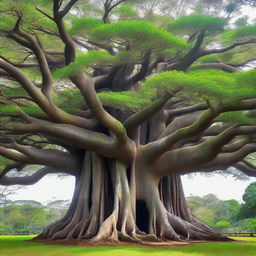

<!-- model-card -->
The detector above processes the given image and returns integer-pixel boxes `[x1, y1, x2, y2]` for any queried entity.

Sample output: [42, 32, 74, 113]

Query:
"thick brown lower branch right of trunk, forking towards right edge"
[157, 126, 256, 176]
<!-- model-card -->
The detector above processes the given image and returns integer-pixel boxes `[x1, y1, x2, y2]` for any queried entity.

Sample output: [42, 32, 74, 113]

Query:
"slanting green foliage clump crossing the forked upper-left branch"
[53, 51, 117, 79]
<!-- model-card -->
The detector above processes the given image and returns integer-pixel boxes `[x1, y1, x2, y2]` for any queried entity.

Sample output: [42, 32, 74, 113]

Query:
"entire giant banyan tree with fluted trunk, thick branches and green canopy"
[0, 0, 256, 242]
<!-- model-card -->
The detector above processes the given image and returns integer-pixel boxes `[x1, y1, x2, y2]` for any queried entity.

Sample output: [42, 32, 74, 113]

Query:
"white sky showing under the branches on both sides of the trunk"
[6, 174, 256, 203]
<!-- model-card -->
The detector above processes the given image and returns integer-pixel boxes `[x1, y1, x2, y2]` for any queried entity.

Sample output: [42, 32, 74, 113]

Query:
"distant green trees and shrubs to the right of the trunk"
[187, 182, 256, 232]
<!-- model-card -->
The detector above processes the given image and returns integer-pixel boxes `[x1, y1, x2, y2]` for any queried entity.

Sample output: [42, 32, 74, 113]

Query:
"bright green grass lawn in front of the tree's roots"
[0, 236, 256, 256]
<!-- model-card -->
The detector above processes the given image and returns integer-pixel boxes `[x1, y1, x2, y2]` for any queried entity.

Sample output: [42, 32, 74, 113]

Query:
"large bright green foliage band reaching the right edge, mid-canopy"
[141, 70, 256, 103]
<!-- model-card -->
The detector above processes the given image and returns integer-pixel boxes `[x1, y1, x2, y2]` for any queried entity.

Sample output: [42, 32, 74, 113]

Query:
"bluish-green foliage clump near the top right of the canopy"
[168, 14, 226, 34]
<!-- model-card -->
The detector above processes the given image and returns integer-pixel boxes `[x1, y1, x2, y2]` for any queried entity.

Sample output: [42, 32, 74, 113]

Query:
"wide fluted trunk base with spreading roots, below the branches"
[35, 152, 229, 244]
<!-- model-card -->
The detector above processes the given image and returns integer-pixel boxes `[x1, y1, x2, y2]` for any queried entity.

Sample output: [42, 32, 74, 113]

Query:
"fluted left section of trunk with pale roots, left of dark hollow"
[37, 152, 135, 241]
